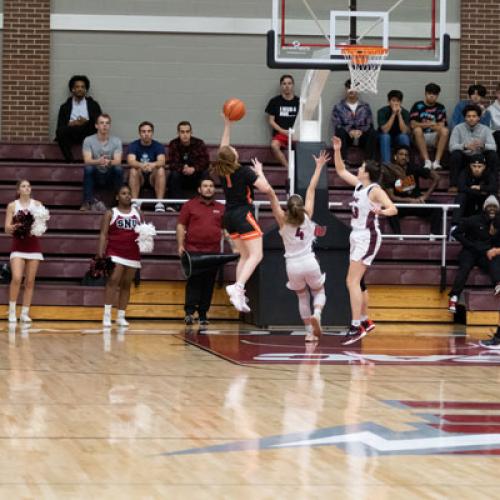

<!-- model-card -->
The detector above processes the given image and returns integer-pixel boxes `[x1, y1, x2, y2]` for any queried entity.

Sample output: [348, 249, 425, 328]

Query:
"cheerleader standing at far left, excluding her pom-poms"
[5, 179, 43, 323]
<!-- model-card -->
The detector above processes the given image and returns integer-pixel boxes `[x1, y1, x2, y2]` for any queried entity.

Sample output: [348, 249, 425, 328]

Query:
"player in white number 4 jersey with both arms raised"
[268, 151, 331, 342]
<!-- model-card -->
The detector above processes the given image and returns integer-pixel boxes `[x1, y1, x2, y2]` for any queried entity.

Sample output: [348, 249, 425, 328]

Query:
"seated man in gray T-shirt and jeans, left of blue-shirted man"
[80, 113, 123, 211]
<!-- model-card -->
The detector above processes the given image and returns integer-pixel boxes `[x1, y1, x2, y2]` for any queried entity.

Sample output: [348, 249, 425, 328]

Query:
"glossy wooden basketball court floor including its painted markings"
[0, 322, 500, 500]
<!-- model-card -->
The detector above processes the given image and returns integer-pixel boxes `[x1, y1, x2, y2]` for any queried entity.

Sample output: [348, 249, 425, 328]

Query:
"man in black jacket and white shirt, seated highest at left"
[56, 75, 102, 163]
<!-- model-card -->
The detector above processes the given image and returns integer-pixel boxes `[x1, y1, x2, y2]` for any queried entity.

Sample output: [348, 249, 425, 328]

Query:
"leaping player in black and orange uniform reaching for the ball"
[213, 116, 271, 312]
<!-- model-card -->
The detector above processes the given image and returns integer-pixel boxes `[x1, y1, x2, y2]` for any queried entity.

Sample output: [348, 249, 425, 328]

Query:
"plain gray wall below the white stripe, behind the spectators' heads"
[51, 32, 459, 144]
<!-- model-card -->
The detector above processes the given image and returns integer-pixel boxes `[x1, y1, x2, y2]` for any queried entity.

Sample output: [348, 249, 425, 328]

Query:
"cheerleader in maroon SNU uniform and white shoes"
[97, 186, 141, 327]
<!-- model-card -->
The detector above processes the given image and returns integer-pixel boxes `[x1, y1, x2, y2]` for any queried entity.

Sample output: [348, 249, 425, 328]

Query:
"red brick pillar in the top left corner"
[1, 0, 50, 142]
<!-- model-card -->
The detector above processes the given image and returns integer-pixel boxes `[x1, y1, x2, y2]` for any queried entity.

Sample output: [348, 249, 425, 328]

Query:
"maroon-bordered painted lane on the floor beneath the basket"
[182, 328, 500, 366]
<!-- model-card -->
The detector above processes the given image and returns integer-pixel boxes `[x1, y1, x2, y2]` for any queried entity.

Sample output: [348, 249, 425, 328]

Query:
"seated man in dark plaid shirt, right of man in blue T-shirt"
[167, 121, 209, 209]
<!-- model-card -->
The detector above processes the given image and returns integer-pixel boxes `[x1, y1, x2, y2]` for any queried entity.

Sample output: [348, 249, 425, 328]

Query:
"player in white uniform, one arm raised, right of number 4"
[332, 137, 398, 345]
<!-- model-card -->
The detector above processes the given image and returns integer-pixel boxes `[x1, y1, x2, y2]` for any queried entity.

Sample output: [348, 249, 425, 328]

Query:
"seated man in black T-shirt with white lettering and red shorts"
[266, 75, 300, 167]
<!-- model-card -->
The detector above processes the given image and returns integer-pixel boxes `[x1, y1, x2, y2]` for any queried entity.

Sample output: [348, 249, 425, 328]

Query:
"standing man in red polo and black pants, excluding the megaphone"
[177, 178, 224, 325]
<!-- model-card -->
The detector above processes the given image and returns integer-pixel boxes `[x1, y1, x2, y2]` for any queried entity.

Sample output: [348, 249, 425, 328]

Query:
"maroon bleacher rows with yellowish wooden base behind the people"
[0, 143, 499, 321]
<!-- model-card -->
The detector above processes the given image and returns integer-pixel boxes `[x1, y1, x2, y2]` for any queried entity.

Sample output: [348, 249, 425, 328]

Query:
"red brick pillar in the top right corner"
[460, 0, 500, 100]
